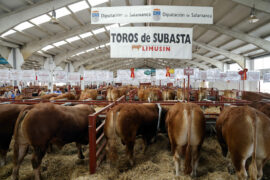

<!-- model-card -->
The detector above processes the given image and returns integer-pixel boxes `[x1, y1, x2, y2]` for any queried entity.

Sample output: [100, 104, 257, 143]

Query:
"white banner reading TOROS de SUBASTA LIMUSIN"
[110, 27, 193, 59]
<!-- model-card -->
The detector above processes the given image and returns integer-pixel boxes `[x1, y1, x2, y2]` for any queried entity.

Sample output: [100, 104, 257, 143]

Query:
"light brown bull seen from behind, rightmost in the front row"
[216, 106, 270, 180]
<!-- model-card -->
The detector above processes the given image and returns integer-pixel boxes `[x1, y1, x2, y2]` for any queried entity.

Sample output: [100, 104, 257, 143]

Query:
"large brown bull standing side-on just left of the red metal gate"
[12, 103, 95, 179]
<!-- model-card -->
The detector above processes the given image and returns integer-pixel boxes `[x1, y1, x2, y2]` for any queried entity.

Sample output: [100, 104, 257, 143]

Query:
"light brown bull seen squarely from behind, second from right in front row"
[166, 103, 205, 176]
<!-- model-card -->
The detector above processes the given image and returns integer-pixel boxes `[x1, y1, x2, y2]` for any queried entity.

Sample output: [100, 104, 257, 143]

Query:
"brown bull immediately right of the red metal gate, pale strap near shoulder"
[104, 104, 167, 165]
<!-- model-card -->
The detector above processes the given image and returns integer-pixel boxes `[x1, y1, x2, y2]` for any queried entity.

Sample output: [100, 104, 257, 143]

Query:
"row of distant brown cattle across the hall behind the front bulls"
[9, 86, 237, 102]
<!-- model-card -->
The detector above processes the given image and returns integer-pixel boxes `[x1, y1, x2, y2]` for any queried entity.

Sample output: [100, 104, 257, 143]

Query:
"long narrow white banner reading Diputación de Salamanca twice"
[91, 5, 213, 24]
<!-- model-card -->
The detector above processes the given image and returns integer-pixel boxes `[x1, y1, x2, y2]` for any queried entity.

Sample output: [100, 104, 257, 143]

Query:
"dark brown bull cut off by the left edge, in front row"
[0, 104, 27, 166]
